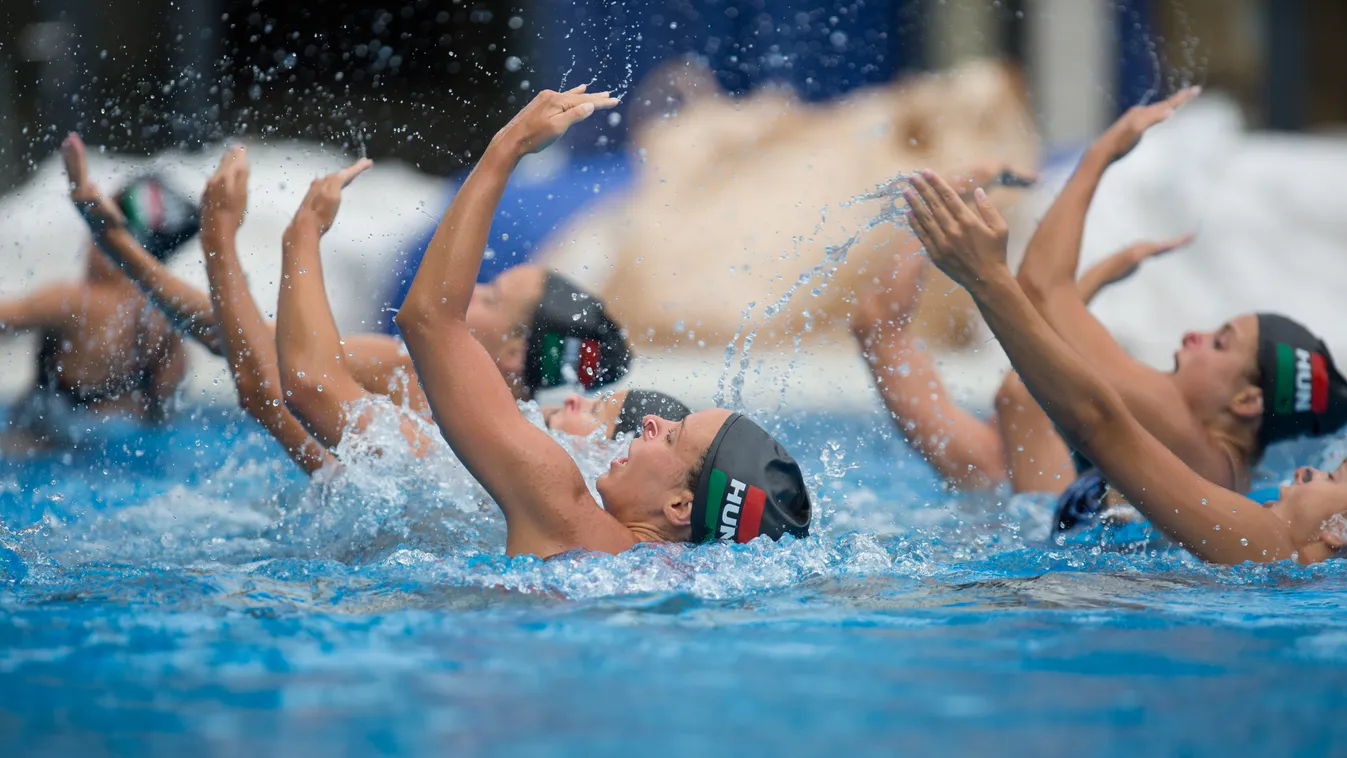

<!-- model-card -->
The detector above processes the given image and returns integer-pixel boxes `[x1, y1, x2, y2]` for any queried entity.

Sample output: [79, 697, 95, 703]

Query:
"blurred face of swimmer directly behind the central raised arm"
[465, 265, 547, 385]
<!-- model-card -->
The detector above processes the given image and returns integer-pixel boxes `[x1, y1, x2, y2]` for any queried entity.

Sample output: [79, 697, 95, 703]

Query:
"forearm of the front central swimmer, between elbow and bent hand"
[397, 140, 519, 332]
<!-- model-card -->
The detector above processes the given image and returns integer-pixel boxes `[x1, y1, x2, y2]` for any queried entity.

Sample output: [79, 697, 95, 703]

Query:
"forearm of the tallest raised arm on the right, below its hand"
[1018, 147, 1110, 302]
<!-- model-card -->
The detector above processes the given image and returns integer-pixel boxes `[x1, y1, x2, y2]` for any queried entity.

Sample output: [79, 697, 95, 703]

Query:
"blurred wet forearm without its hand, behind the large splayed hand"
[862, 334, 1006, 487]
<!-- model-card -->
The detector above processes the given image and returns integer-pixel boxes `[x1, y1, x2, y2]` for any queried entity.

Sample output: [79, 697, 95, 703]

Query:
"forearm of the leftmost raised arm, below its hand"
[94, 226, 224, 355]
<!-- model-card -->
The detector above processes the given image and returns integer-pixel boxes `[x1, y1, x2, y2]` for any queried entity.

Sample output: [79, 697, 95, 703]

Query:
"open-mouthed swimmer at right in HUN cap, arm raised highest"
[851, 89, 1347, 526]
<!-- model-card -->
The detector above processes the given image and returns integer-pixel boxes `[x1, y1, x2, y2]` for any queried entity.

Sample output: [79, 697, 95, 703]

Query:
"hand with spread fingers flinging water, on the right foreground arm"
[902, 170, 1009, 289]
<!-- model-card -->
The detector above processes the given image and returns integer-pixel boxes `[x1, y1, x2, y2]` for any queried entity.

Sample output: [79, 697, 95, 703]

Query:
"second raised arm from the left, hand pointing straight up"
[201, 145, 331, 474]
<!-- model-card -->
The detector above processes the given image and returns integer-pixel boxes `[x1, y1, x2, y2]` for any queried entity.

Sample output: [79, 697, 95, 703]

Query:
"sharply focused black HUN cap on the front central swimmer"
[692, 413, 810, 543]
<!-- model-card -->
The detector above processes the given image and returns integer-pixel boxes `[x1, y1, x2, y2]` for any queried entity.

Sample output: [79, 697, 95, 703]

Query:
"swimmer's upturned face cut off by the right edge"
[1270, 460, 1347, 560]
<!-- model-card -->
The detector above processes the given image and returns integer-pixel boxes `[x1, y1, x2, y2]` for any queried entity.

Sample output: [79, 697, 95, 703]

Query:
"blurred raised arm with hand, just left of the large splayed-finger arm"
[851, 245, 1006, 487]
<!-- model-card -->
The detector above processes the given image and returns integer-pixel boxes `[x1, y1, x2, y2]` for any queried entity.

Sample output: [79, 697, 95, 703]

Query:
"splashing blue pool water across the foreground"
[0, 408, 1347, 757]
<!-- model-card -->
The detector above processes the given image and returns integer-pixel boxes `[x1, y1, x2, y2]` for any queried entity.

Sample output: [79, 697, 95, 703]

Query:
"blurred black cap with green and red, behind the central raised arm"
[524, 272, 632, 393]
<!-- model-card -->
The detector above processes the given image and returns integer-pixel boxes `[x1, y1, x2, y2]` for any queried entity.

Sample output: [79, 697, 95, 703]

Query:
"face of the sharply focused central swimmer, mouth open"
[598, 408, 730, 540]
